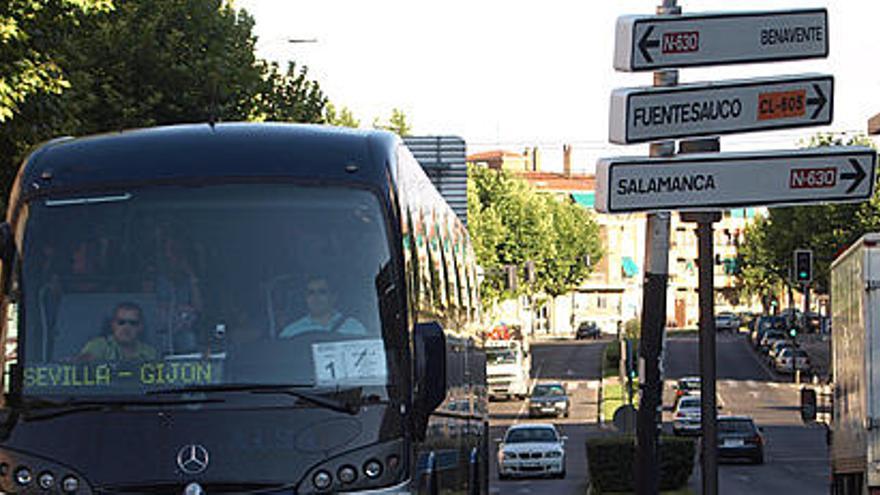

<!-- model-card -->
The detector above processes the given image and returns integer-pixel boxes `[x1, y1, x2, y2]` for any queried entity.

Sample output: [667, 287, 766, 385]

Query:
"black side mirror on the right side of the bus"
[413, 321, 446, 440]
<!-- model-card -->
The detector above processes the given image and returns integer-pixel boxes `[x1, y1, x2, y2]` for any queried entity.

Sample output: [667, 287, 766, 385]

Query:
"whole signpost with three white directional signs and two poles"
[596, 0, 844, 495]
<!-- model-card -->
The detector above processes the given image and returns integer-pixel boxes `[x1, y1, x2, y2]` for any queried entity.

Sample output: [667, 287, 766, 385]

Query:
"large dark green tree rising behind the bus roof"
[0, 0, 327, 202]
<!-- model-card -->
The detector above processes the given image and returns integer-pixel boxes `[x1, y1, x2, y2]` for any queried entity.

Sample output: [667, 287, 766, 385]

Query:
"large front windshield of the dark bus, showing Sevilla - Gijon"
[19, 184, 396, 398]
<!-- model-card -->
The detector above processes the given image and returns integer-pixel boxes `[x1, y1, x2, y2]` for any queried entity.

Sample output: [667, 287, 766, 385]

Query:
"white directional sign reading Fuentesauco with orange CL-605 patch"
[609, 74, 834, 144]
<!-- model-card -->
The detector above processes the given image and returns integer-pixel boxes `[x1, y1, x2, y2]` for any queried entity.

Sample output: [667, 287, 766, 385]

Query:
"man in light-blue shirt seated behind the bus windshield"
[280, 277, 367, 338]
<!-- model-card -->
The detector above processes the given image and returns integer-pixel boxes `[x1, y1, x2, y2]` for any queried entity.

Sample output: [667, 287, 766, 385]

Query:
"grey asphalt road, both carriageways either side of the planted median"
[489, 335, 829, 495]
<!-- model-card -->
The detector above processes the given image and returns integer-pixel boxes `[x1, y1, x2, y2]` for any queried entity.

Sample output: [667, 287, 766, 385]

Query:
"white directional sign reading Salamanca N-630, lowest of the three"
[596, 146, 877, 213]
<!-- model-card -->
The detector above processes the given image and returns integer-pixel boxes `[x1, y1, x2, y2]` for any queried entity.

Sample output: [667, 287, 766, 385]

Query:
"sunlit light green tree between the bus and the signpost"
[468, 166, 601, 301]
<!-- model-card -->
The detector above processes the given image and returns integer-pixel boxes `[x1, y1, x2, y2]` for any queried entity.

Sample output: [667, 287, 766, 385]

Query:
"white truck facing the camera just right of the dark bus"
[486, 339, 532, 399]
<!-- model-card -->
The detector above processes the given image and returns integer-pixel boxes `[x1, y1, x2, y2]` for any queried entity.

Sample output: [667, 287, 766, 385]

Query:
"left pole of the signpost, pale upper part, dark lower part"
[635, 0, 681, 495]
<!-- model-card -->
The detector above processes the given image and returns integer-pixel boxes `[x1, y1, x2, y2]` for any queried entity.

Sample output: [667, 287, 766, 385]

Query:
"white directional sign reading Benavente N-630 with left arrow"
[614, 9, 828, 72]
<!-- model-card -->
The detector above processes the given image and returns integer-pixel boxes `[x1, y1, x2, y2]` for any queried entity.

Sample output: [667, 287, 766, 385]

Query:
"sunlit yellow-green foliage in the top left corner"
[0, 0, 112, 123]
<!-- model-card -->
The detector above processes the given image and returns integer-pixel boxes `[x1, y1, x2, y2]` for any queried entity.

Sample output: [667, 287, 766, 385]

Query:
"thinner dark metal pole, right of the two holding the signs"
[679, 138, 721, 495]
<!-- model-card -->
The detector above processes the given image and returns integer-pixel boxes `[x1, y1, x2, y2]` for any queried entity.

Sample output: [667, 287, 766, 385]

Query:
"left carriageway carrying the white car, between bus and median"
[489, 341, 605, 495]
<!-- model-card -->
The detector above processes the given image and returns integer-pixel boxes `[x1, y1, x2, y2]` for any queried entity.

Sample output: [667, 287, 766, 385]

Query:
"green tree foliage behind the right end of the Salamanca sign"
[738, 134, 880, 295]
